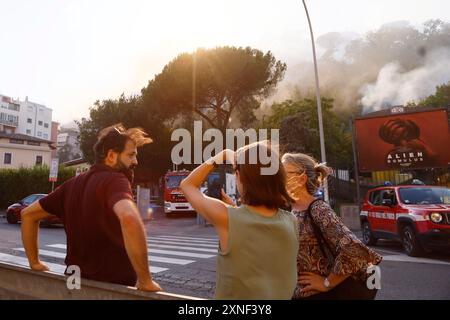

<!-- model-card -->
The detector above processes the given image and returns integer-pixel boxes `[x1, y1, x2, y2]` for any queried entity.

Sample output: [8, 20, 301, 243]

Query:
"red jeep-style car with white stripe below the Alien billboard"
[360, 185, 450, 256]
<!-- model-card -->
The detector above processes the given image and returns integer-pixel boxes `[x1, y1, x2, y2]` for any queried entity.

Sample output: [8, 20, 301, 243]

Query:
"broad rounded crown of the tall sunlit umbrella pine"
[142, 47, 286, 132]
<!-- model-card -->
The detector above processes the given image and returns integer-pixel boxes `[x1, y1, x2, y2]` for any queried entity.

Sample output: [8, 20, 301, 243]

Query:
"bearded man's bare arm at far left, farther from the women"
[21, 201, 50, 271]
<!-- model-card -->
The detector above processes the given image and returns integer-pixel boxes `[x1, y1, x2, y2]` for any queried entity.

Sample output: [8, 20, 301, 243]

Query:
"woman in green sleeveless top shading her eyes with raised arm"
[181, 142, 299, 300]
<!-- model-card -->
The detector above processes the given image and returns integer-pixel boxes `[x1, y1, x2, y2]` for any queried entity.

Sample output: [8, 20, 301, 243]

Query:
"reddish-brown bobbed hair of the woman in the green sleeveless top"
[235, 141, 293, 209]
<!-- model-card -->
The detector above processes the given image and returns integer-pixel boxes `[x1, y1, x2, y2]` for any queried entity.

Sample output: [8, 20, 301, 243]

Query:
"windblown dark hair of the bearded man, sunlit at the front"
[94, 123, 153, 163]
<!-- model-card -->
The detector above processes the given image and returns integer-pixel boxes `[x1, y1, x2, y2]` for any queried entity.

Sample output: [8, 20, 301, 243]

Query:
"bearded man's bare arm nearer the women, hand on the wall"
[113, 199, 162, 291]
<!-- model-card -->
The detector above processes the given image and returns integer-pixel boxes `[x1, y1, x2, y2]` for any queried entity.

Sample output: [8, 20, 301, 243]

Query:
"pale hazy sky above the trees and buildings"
[0, 0, 450, 124]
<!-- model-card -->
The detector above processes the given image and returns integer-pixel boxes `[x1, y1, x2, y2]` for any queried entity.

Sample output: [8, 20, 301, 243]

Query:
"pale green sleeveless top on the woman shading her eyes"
[215, 205, 299, 300]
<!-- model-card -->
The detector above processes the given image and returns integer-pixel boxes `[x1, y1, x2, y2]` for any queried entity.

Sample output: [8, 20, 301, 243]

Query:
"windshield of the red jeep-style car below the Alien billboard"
[400, 187, 450, 204]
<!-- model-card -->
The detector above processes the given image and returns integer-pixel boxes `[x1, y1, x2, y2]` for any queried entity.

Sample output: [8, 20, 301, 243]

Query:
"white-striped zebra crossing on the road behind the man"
[0, 235, 219, 274]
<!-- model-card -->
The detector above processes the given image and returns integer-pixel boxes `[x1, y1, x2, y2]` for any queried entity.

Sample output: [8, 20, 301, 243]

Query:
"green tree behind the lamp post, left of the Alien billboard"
[262, 98, 352, 168]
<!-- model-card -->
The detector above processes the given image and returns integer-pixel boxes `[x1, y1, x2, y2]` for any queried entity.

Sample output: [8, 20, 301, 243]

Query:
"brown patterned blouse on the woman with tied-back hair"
[293, 200, 382, 299]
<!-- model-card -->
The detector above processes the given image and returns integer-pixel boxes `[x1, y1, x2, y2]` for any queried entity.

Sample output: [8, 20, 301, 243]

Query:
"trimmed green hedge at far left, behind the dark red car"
[0, 166, 75, 210]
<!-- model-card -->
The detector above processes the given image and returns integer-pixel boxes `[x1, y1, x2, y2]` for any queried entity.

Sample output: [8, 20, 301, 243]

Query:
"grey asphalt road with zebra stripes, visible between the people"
[0, 207, 450, 300]
